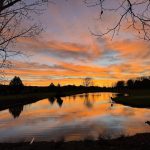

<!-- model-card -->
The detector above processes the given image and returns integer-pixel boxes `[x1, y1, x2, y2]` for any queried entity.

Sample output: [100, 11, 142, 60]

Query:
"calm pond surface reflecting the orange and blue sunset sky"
[0, 93, 150, 142]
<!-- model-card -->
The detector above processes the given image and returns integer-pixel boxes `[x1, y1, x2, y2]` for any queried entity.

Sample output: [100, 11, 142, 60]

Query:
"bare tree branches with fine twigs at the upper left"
[0, 0, 52, 68]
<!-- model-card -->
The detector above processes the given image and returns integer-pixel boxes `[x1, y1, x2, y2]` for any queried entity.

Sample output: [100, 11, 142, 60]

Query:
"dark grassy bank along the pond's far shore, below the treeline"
[0, 88, 150, 110]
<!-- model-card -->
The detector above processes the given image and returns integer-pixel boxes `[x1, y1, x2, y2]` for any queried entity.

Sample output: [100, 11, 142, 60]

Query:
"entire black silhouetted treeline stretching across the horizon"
[0, 77, 150, 95]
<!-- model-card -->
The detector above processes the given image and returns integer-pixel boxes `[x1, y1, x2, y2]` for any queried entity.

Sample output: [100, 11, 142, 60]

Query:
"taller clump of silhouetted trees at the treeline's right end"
[115, 76, 150, 89]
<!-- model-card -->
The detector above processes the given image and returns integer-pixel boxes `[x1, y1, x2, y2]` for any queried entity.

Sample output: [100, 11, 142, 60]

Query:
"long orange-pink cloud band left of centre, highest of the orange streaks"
[18, 38, 101, 60]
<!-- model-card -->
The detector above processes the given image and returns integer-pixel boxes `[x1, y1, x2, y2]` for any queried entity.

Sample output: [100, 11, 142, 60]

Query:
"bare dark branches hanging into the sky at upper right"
[84, 0, 150, 40]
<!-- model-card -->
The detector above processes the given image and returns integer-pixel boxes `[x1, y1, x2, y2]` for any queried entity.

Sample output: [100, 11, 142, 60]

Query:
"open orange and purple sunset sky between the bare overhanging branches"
[6, 0, 150, 86]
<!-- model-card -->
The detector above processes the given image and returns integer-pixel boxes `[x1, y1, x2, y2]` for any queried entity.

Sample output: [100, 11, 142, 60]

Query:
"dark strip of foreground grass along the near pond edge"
[0, 133, 150, 150]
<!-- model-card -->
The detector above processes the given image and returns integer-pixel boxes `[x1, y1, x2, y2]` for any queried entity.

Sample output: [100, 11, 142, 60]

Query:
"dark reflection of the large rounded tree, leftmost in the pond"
[9, 105, 23, 118]
